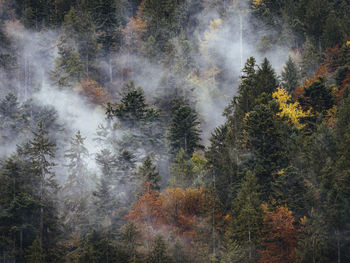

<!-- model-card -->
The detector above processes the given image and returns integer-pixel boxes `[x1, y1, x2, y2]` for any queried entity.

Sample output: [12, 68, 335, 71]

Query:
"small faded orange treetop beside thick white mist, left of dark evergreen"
[77, 80, 107, 104]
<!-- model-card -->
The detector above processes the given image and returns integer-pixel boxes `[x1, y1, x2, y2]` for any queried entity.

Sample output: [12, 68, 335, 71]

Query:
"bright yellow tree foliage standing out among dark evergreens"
[272, 88, 311, 129]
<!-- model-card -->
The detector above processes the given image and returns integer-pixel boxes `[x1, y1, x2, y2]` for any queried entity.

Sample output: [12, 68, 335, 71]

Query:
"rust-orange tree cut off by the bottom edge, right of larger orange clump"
[259, 206, 299, 263]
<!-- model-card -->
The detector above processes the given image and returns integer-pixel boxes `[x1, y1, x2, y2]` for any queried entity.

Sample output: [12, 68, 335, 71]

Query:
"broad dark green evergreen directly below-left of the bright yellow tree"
[244, 104, 290, 200]
